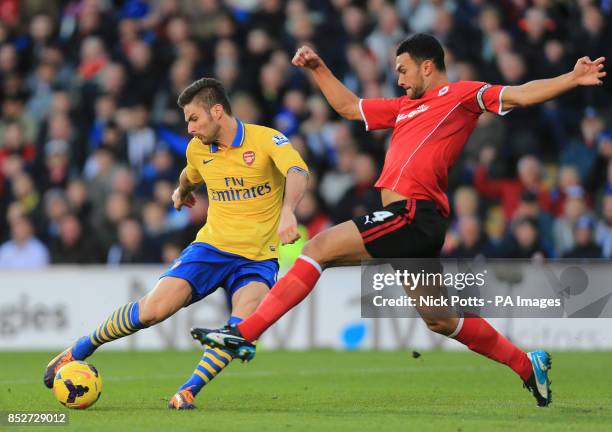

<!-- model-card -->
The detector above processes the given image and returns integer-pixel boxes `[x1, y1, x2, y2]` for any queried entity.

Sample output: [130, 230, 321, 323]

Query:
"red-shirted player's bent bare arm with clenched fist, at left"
[291, 46, 363, 120]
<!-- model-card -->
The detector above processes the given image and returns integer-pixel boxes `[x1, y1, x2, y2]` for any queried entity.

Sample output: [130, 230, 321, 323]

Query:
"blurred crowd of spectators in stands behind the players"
[0, 0, 612, 268]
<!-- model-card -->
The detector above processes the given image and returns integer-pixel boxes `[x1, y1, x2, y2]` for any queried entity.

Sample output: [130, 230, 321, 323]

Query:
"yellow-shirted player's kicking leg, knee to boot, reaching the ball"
[43, 277, 191, 388]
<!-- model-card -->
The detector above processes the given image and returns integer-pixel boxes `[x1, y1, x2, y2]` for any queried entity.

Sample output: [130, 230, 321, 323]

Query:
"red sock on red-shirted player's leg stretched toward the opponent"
[238, 256, 321, 342]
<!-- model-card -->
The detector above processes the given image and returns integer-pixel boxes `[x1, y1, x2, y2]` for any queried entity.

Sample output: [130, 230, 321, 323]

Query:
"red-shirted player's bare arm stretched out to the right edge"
[502, 57, 606, 111]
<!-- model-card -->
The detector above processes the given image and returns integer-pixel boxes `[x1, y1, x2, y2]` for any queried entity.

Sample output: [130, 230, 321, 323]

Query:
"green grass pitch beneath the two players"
[0, 350, 612, 432]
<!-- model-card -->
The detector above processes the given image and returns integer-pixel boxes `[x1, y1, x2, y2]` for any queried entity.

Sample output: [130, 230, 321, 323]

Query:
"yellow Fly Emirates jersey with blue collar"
[186, 119, 308, 261]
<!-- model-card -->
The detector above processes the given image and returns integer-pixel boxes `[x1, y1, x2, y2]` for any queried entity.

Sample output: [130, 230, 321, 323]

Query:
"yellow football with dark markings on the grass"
[53, 361, 102, 409]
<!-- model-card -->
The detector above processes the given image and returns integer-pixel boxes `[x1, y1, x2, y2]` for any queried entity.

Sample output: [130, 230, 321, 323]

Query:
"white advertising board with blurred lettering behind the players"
[0, 266, 612, 351]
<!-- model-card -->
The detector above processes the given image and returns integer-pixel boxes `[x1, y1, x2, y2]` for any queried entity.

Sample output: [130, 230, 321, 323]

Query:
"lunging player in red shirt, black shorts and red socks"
[192, 34, 606, 406]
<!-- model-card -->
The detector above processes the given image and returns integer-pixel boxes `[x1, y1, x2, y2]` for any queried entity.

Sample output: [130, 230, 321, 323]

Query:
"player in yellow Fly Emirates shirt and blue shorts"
[44, 78, 308, 409]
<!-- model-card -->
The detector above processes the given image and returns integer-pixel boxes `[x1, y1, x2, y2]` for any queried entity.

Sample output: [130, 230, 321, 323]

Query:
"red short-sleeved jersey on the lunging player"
[359, 81, 508, 216]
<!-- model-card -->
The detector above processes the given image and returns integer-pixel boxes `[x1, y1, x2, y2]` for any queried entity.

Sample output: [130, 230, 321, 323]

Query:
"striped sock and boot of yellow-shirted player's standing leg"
[168, 316, 242, 410]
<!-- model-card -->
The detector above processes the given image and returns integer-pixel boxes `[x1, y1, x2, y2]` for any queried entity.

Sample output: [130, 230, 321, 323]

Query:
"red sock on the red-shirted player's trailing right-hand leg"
[451, 314, 532, 381]
